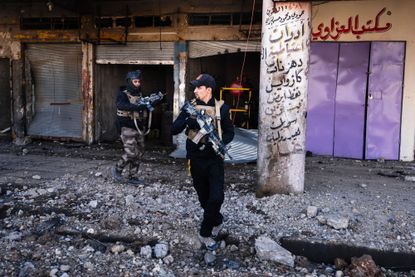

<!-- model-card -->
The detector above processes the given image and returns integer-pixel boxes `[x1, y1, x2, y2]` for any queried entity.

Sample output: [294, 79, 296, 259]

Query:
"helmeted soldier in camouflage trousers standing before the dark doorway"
[112, 70, 148, 184]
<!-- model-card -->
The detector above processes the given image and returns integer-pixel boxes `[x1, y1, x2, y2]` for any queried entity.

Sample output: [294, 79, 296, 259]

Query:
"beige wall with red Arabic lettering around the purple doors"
[312, 0, 415, 161]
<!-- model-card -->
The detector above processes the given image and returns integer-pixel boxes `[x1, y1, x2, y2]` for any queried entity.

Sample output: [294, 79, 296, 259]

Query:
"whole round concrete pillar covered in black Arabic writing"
[256, 0, 311, 197]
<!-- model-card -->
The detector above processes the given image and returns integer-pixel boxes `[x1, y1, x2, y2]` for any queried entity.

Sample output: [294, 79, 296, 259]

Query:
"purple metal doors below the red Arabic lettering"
[306, 42, 405, 160]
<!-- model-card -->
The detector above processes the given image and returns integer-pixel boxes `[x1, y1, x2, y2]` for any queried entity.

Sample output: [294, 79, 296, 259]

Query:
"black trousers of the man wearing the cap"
[190, 156, 225, 237]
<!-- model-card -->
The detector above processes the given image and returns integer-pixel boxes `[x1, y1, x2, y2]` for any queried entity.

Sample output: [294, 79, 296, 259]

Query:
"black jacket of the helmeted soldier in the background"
[116, 87, 145, 130]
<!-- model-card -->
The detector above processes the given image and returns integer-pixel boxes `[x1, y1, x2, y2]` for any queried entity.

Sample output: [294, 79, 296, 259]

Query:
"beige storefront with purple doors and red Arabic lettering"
[307, 1, 415, 160]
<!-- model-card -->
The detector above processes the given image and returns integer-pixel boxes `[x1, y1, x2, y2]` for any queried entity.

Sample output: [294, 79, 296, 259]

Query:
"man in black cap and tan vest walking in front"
[171, 74, 234, 250]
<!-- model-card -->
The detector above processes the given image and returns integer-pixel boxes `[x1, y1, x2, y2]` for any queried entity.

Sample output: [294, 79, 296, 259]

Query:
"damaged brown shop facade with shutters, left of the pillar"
[0, 0, 262, 146]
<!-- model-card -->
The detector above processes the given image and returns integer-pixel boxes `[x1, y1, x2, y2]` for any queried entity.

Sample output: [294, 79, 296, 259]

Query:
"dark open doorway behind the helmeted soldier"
[95, 64, 174, 144]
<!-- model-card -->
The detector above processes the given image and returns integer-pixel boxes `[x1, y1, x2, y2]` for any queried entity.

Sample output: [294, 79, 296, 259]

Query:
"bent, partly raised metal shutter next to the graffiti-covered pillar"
[189, 41, 261, 58]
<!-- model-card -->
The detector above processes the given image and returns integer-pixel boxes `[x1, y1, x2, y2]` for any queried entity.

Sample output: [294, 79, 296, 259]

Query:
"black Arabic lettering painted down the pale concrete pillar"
[261, 2, 311, 154]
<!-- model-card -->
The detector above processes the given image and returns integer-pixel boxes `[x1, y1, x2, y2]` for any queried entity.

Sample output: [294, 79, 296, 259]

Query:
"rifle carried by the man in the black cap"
[182, 101, 232, 160]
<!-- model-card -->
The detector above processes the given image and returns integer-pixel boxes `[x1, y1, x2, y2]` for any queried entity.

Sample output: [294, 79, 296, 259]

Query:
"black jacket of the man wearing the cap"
[171, 97, 235, 159]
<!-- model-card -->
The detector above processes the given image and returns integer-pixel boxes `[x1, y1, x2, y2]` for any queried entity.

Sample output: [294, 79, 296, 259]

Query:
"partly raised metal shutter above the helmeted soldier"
[96, 42, 174, 64]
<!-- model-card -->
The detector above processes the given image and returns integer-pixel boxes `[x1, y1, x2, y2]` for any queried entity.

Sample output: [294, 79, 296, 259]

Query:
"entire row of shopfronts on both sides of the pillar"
[0, 0, 415, 161]
